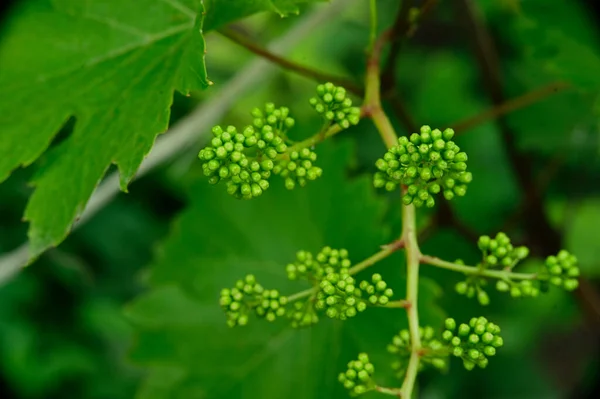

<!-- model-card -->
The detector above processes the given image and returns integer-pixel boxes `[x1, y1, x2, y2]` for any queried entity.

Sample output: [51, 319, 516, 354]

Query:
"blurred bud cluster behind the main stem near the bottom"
[387, 326, 448, 378]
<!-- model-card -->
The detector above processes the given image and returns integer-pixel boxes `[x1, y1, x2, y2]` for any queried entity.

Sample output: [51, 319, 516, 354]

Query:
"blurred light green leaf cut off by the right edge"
[565, 198, 600, 278]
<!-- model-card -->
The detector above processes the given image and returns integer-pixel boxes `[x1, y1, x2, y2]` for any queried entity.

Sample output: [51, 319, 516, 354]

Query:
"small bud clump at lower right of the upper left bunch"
[273, 148, 323, 190]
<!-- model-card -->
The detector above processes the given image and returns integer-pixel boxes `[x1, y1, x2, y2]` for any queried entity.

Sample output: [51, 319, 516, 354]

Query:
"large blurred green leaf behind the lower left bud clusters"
[127, 145, 442, 399]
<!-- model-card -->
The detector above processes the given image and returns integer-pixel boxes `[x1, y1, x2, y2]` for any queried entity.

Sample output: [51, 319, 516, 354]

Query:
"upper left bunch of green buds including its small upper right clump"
[198, 83, 360, 199]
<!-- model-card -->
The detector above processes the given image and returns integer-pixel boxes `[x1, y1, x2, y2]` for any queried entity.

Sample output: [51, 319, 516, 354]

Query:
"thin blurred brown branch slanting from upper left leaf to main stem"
[219, 29, 364, 97]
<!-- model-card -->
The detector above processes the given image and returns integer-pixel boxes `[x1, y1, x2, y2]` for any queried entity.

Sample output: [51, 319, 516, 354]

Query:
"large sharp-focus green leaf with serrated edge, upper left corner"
[0, 0, 208, 256]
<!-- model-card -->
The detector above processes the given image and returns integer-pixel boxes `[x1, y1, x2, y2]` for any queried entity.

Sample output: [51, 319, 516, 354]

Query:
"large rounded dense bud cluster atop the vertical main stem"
[373, 126, 473, 207]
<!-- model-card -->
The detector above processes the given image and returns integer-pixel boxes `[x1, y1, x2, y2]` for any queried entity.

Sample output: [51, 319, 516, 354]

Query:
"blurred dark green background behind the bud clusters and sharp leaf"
[0, 0, 600, 399]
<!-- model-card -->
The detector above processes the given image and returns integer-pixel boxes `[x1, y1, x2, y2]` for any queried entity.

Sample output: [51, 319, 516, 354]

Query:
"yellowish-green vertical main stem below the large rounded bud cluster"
[401, 198, 421, 399]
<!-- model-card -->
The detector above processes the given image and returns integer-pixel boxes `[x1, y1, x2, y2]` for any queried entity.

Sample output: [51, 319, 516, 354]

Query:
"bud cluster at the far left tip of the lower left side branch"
[219, 274, 287, 327]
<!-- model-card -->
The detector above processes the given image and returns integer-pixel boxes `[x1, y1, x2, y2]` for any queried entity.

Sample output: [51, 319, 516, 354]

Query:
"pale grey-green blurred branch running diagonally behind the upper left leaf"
[0, 0, 357, 284]
